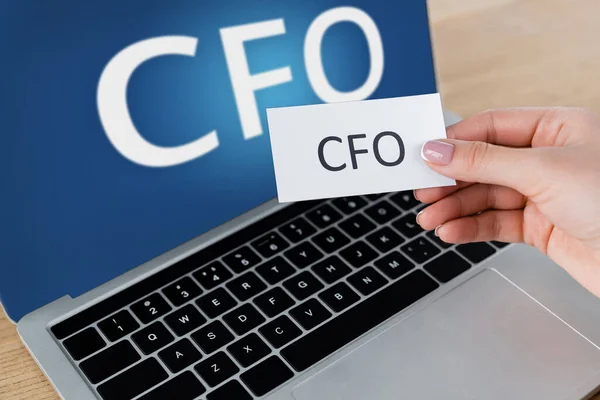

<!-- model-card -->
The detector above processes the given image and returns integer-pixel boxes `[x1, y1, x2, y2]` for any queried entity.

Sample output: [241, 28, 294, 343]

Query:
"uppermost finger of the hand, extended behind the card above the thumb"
[447, 107, 581, 147]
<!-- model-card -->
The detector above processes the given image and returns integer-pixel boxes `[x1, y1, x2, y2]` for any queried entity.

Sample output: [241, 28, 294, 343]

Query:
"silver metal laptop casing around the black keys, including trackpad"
[18, 110, 600, 400]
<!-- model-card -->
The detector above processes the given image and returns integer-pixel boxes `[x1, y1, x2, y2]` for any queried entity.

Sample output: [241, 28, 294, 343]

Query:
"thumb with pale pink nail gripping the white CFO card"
[421, 139, 549, 196]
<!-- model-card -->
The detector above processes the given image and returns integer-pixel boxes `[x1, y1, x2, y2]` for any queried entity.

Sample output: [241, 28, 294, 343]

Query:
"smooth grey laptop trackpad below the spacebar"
[293, 270, 600, 400]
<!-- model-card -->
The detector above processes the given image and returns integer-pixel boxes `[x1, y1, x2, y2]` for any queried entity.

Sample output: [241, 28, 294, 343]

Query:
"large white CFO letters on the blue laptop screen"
[97, 7, 384, 167]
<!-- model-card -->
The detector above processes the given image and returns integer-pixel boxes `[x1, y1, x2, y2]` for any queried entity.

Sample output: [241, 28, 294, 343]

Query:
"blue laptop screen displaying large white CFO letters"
[0, 0, 436, 320]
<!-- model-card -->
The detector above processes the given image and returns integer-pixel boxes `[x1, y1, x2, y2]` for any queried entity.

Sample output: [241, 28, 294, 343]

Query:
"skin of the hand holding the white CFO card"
[415, 108, 600, 297]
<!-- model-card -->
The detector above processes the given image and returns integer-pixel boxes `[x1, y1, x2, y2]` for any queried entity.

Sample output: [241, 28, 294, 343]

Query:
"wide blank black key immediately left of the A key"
[98, 358, 169, 400]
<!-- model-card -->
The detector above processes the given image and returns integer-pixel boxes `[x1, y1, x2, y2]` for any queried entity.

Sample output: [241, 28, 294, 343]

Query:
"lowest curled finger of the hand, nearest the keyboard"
[436, 210, 523, 244]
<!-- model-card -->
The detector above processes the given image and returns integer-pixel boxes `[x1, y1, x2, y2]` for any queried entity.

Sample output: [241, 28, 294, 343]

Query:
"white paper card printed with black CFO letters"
[267, 94, 456, 203]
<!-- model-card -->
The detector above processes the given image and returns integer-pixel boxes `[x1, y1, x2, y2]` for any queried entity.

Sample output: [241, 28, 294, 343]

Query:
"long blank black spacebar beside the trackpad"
[281, 270, 439, 371]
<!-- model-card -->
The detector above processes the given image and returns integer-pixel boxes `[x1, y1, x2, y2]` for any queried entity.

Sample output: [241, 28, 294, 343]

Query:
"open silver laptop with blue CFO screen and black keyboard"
[5, 0, 600, 400]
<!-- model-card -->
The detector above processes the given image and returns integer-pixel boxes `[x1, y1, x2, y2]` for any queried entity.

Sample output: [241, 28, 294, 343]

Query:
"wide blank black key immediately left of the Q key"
[79, 340, 141, 384]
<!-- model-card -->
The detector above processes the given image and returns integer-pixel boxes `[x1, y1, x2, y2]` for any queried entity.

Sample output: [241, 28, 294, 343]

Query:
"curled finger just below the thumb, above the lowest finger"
[417, 184, 526, 230]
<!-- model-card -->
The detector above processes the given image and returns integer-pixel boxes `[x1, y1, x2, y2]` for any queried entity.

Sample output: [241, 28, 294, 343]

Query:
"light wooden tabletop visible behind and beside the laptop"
[0, 0, 600, 400]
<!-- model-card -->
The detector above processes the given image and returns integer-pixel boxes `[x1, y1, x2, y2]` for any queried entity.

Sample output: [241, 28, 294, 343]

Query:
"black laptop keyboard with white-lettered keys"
[51, 192, 505, 400]
